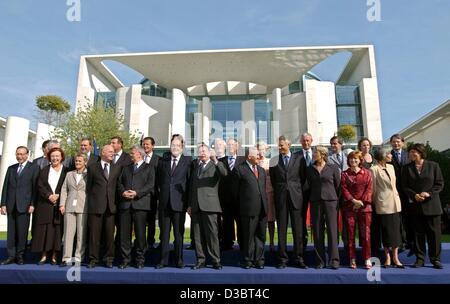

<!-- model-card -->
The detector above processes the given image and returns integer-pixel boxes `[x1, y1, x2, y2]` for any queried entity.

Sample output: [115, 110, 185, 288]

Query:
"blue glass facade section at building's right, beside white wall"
[336, 86, 364, 139]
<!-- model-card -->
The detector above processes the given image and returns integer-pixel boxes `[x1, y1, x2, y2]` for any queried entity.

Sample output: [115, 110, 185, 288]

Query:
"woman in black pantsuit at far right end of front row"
[402, 144, 444, 269]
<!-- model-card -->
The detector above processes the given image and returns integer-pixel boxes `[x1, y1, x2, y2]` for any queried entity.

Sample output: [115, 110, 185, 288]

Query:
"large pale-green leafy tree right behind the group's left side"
[52, 105, 138, 156]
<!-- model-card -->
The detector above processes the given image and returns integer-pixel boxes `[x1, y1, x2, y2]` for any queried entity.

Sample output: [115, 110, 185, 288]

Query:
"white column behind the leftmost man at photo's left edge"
[0, 116, 30, 231]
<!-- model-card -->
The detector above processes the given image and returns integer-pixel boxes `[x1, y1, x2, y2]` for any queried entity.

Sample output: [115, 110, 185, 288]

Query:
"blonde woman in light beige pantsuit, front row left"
[60, 153, 88, 267]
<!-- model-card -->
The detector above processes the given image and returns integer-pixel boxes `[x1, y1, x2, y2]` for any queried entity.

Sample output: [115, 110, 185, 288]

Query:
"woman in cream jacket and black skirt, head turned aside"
[370, 148, 404, 268]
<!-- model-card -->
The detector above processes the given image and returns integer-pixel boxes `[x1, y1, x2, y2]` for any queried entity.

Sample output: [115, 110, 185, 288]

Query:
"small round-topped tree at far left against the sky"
[36, 95, 70, 127]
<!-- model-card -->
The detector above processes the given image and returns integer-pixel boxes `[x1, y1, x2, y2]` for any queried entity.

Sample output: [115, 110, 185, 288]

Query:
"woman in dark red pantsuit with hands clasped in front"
[341, 151, 372, 269]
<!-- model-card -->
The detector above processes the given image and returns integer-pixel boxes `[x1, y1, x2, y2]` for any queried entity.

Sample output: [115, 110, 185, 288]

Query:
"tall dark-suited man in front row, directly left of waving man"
[155, 135, 192, 269]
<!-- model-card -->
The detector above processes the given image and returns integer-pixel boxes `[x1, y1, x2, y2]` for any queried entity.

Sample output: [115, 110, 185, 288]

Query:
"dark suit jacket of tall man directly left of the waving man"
[156, 155, 192, 212]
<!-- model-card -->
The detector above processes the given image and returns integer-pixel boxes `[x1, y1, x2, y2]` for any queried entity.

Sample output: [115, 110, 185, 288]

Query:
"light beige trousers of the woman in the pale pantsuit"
[62, 212, 88, 263]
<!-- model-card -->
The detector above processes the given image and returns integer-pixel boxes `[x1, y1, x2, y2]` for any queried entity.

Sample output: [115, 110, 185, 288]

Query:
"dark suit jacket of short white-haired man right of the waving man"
[231, 162, 268, 216]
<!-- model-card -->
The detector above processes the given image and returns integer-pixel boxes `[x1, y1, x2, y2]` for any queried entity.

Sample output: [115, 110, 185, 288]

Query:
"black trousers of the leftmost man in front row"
[7, 206, 30, 258]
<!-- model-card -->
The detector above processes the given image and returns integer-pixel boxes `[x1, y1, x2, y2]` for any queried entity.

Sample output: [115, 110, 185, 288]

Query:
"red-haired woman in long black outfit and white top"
[31, 148, 67, 265]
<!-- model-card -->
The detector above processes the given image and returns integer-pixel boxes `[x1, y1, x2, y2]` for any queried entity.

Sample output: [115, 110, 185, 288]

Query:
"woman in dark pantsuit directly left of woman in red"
[306, 146, 341, 269]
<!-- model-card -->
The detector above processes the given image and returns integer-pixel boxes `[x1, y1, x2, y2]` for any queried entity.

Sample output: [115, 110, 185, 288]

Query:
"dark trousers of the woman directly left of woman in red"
[311, 201, 339, 265]
